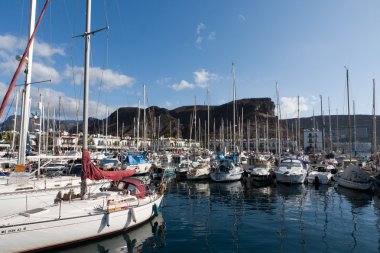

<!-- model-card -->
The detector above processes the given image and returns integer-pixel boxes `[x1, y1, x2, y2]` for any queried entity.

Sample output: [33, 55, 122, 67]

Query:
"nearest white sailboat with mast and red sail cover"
[0, 0, 165, 252]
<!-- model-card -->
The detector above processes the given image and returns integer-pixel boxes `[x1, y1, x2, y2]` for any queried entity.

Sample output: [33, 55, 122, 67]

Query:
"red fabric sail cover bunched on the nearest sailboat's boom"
[82, 150, 135, 180]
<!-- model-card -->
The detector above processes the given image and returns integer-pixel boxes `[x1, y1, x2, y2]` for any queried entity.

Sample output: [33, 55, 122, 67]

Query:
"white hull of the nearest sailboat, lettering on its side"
[0, 196, 163, 252]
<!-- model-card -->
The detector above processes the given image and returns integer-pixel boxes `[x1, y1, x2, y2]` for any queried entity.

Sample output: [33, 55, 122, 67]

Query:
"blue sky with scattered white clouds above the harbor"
[0, 0, 380, 119]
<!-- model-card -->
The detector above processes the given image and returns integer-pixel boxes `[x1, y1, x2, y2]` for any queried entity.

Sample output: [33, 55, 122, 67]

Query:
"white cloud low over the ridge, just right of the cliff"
[280, 97, 309, 119]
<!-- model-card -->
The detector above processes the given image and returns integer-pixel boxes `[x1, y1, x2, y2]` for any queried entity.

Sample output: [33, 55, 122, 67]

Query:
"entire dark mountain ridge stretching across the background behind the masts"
[2, 98, 380, 146]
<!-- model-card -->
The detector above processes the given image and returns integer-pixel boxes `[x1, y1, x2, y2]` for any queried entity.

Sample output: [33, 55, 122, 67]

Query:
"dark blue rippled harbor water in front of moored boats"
[54, 180, 380, 253]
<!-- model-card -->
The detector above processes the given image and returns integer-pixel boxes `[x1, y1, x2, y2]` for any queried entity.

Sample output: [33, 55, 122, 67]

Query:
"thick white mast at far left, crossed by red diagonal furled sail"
[18, 0, 36, 164]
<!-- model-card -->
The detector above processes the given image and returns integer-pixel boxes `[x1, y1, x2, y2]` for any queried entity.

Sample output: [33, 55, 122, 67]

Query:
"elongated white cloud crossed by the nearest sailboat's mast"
[65, 65, 135, 91]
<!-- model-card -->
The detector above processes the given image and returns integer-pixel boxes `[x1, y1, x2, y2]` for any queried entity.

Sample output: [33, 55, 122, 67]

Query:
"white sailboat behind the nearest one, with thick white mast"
[0, 1, 108, 217]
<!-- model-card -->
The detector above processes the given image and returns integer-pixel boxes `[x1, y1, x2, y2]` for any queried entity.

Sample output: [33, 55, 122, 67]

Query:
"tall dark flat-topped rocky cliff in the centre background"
[83, 98, 276, 139]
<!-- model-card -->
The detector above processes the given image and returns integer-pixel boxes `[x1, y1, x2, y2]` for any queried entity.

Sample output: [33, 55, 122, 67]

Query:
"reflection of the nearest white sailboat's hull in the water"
[54, 214, 166, 253]
